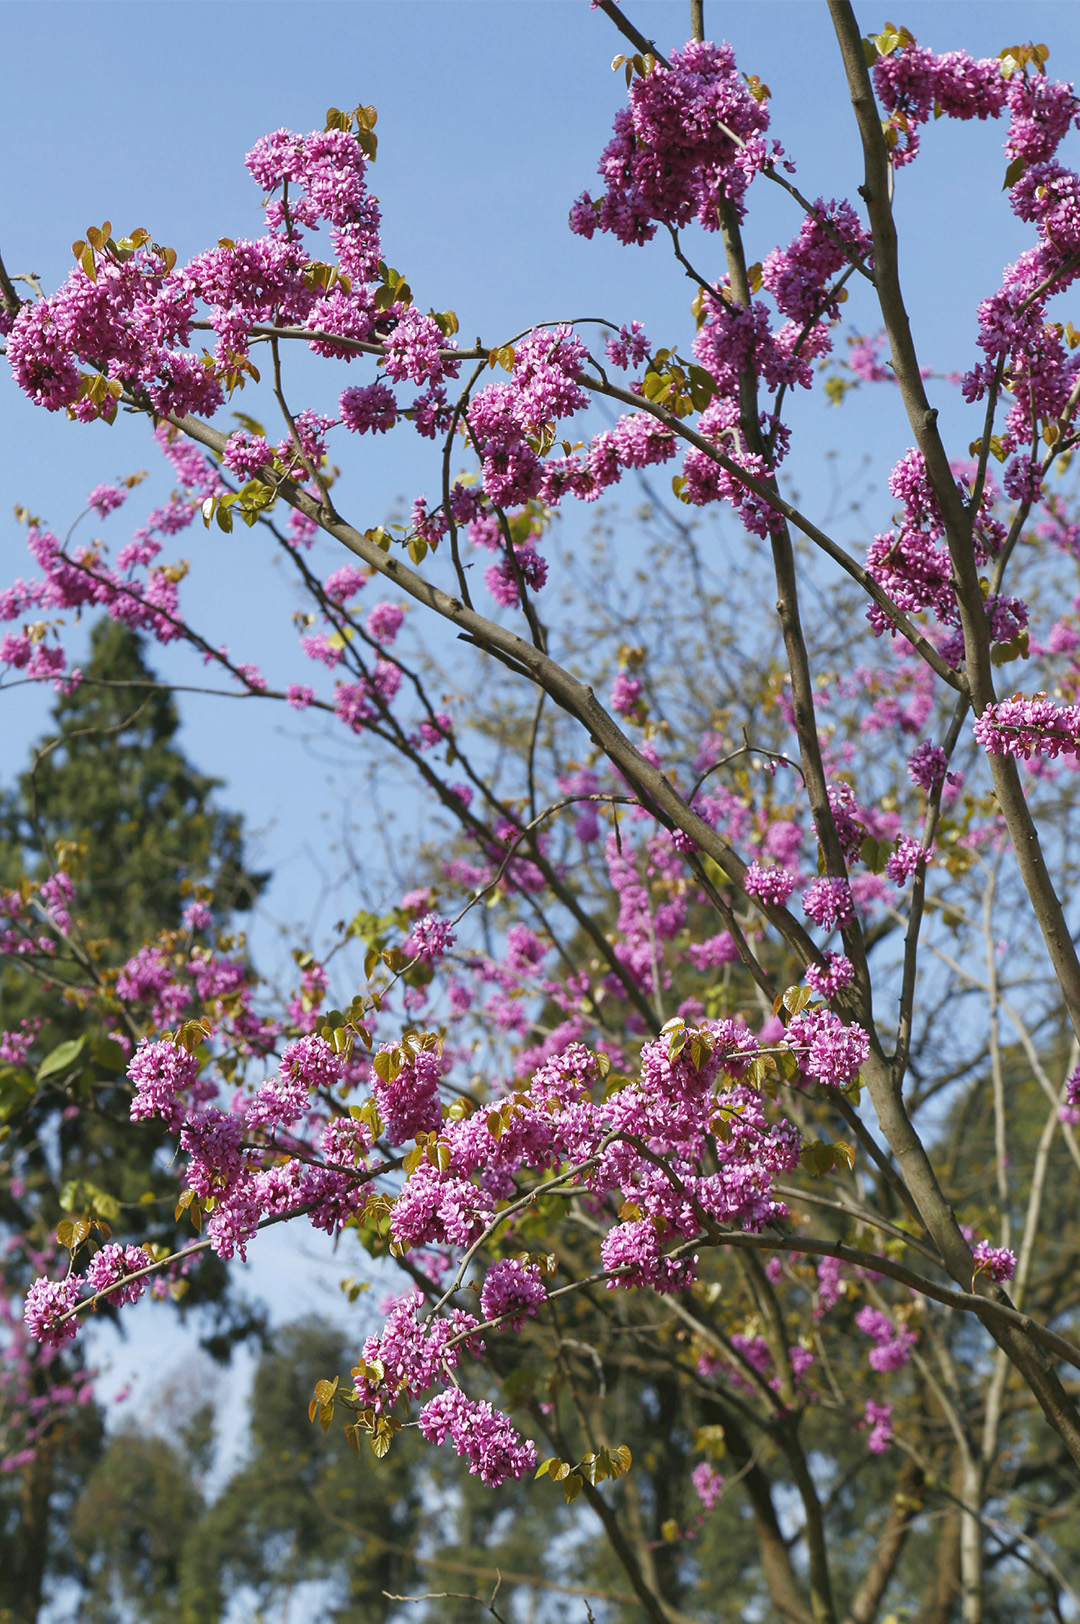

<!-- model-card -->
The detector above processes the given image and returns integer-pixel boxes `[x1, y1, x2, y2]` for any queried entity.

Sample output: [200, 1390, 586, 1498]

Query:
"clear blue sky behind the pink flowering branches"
[0, 0, 1080, 1448]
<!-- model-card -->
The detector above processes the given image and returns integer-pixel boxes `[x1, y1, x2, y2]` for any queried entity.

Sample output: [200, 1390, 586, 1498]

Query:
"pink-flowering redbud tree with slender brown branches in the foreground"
[0, 0, 1080, 1624]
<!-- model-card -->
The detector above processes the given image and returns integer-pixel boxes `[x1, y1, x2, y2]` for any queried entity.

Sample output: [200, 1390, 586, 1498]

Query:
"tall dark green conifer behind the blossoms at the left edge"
[0, 620, 265, 1624]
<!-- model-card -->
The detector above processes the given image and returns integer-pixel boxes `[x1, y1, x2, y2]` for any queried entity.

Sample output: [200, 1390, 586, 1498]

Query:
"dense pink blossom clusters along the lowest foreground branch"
[24, 993, 867, 1483]
